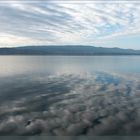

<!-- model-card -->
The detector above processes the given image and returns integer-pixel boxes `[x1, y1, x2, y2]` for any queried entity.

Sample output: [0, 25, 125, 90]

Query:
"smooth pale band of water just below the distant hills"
[0, 56, 140, 76]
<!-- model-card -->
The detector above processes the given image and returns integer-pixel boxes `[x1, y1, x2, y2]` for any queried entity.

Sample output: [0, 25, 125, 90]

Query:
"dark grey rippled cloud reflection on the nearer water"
[0, 73, 140, 136]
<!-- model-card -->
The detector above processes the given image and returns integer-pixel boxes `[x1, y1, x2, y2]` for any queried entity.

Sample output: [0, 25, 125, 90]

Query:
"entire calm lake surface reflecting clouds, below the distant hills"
[0, 56, 140, 135]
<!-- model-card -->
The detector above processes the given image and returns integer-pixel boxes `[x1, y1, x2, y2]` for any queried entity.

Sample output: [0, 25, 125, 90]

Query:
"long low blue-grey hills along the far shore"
[0, 45, 140, 56]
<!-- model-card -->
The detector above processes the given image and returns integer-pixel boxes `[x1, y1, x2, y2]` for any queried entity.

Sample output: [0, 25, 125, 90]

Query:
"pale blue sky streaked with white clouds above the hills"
[0, 0, 140, 49]
